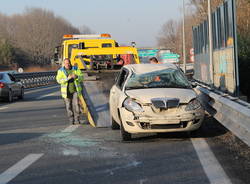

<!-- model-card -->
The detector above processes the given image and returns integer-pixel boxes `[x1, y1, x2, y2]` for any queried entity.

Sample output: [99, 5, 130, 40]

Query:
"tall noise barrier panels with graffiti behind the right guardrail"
[193, 0, 239, 95]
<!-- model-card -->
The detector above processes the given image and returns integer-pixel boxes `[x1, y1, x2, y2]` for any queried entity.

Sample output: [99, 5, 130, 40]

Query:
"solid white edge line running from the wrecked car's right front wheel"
[191, 138, 232, 184]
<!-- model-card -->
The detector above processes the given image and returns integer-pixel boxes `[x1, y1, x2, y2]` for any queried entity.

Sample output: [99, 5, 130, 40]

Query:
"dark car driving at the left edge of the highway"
[0, 72, 24, 102]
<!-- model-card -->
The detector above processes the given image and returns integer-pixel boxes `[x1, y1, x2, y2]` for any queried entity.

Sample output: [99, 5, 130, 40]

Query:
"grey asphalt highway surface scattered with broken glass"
[0, 77, 250, 184]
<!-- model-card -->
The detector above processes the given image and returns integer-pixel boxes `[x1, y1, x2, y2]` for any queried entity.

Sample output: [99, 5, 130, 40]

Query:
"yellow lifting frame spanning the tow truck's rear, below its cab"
[70, 47, 140, 70]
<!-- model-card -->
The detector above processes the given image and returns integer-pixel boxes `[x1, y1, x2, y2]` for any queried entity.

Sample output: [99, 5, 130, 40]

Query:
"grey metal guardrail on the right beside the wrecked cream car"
[197, 84, 250, 146]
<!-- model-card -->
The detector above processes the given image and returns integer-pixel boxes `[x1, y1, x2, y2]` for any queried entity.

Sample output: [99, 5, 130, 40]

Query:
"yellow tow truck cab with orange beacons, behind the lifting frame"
[53, 34, 119, 69]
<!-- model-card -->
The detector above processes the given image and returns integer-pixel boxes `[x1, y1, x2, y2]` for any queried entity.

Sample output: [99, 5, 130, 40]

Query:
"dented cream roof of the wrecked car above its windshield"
[124, 63, 178, 74]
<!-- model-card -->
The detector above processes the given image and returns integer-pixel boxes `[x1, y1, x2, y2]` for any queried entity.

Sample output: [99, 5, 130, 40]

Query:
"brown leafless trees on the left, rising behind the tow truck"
[0, 8, 79, 65]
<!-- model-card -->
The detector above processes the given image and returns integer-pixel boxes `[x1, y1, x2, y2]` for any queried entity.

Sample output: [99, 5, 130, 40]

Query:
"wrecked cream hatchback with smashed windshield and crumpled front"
[109, 64, 204, 140]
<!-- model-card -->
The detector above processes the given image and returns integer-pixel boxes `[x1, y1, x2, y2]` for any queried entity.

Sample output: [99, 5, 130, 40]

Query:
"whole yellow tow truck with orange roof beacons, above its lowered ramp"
[53, 33, 139, 70]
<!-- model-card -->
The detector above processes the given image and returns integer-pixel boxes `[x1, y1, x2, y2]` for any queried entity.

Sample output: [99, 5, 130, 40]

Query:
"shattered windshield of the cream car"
[125, 68, 191, 90]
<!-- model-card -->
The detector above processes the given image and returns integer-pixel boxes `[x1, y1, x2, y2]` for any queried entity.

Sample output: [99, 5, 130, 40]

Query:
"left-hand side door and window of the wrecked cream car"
[109, 68, 129, 122]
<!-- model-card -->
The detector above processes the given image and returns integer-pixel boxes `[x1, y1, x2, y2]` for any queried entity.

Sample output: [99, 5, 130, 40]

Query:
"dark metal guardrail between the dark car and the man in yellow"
[12, 71, 56, 88]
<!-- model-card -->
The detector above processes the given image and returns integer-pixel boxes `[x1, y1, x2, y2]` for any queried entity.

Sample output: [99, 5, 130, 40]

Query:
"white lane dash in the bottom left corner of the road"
[0, 154, 43, 184]
